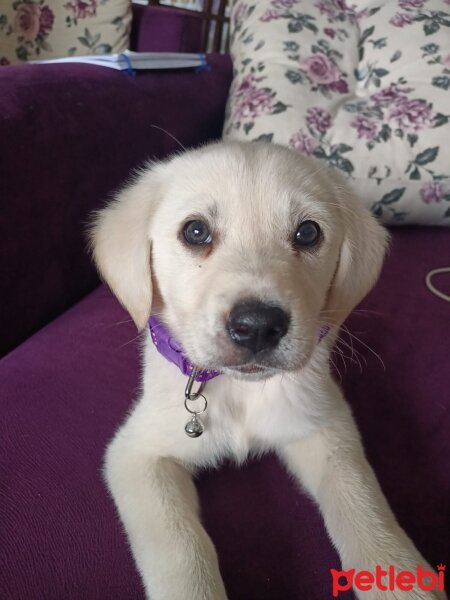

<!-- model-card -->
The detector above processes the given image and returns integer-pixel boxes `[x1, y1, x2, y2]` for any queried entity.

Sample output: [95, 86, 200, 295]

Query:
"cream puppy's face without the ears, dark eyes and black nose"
[150, 146, 342, 377]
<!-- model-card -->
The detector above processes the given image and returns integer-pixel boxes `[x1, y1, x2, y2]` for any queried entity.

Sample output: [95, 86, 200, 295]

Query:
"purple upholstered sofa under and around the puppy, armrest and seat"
[0, 9, 450, 600]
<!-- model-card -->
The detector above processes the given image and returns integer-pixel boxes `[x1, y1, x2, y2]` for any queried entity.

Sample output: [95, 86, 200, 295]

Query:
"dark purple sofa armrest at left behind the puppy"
[0, 55, 231, 354]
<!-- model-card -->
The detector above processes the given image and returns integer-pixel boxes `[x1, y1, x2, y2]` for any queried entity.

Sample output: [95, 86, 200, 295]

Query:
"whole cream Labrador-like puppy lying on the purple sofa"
[91, 143, 440, 600]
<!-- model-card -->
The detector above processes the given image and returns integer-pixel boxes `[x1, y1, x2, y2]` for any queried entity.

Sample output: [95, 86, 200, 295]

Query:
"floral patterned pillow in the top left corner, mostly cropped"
[0, 0, 131, 65]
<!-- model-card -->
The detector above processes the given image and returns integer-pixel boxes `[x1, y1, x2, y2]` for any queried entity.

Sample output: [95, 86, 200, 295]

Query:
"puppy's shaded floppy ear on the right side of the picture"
[326, 183, 389, 325]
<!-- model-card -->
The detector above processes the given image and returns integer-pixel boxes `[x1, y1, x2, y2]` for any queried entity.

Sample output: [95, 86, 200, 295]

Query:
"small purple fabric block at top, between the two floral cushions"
[130, 5, 202, 52]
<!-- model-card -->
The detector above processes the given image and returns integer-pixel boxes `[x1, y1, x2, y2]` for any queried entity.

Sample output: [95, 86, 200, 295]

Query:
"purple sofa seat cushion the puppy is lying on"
[0, 228, 450, 600]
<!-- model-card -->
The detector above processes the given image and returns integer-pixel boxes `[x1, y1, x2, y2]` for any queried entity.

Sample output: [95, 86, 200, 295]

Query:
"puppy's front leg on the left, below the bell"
[105, 416, 226, 600]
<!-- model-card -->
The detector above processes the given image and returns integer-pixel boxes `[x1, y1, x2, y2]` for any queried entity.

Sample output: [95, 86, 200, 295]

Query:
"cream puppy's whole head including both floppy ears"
[92, 143, 387, 378]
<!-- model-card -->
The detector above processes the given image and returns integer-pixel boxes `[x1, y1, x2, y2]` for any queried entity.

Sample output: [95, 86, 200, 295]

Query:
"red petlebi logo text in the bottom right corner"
[330, 564, 445, 598]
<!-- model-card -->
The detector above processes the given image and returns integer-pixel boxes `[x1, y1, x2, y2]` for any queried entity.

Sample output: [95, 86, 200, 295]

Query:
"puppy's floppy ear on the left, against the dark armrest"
[89, 171, 160, 329]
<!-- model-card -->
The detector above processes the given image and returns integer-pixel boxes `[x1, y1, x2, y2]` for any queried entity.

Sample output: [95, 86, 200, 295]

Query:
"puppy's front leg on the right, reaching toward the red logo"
[279, 387, 446, 600]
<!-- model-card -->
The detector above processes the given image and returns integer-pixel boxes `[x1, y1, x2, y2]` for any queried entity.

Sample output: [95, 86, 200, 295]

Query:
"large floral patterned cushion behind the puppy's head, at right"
[224, 0, 450, 225]
